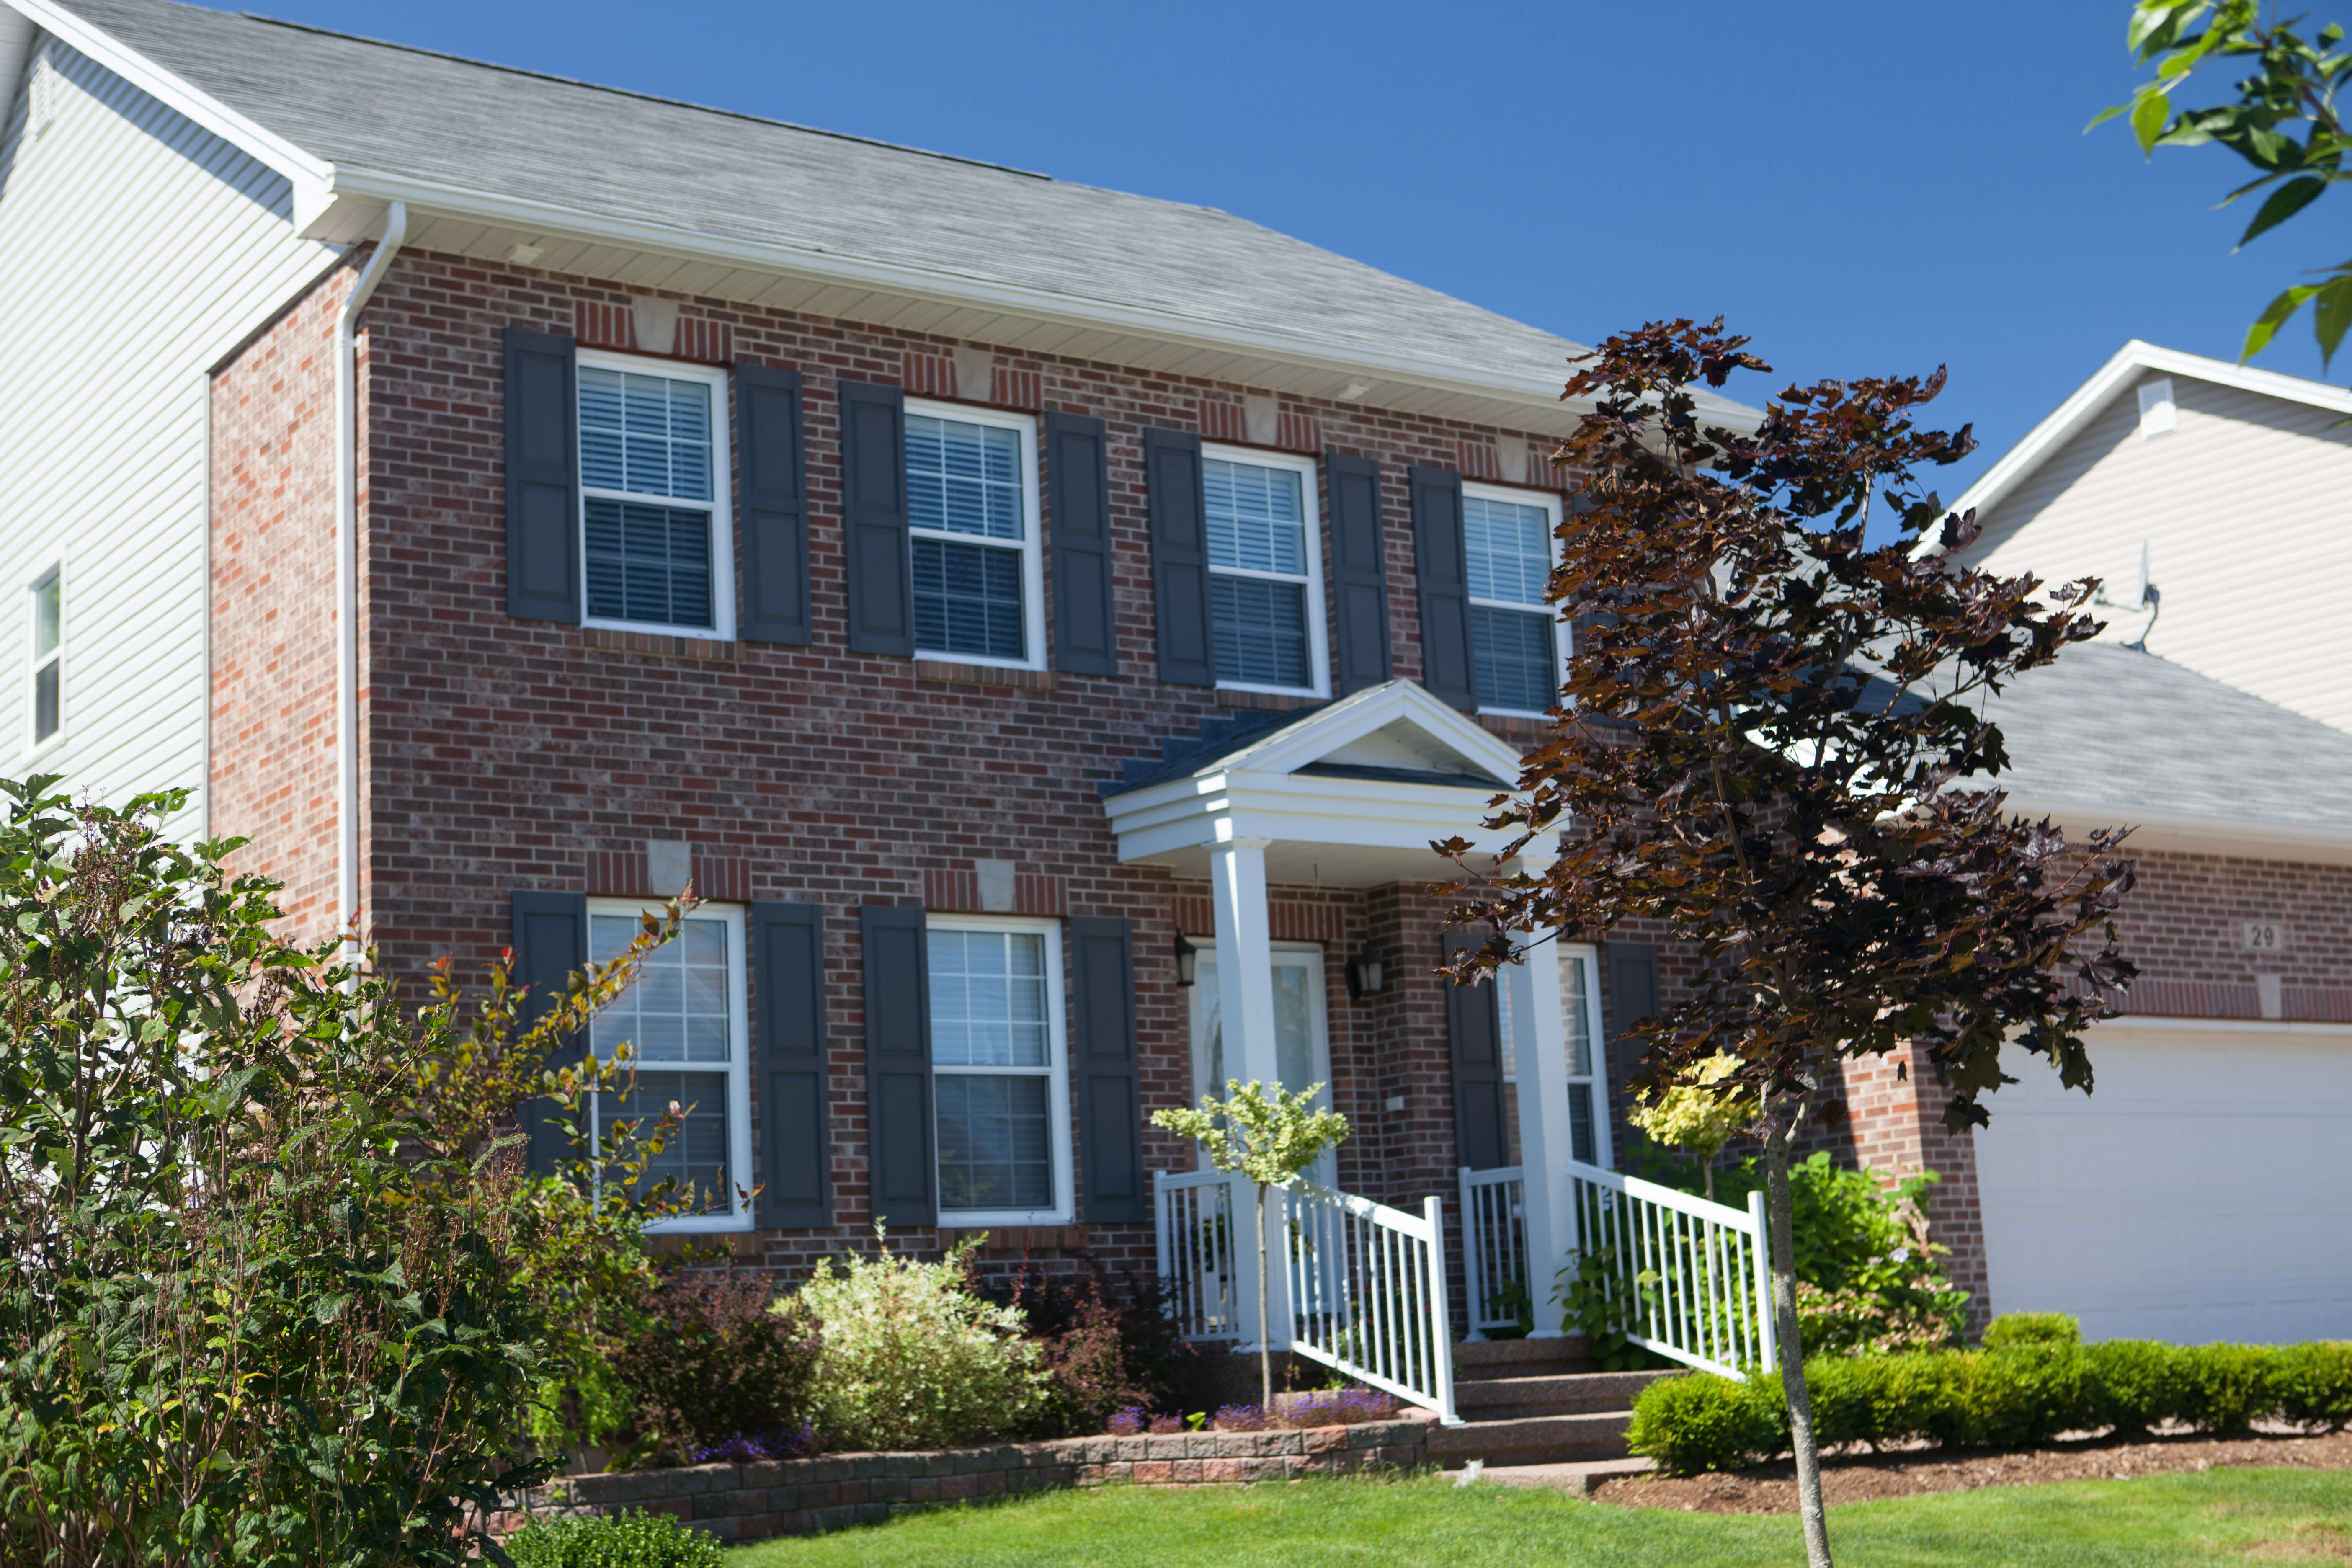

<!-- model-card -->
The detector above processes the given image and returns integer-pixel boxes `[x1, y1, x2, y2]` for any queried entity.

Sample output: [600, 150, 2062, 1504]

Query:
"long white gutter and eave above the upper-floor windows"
[308, 170, 1755, 428]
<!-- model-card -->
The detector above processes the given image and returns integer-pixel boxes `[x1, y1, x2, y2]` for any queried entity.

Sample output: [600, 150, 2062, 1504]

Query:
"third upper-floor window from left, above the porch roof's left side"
[1199, 447, 1329, 696]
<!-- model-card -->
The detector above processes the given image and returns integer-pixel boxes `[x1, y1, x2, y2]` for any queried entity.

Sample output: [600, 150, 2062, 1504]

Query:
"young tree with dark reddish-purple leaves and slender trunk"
[1439, 320, 2133, 1565]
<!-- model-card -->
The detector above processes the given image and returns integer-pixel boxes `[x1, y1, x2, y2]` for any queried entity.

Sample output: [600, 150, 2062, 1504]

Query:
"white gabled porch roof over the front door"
[1103, 679, 1519, 886]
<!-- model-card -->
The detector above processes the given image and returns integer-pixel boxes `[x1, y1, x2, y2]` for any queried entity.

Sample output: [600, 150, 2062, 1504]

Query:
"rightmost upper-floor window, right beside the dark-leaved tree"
[1463, 484, 1566, 717]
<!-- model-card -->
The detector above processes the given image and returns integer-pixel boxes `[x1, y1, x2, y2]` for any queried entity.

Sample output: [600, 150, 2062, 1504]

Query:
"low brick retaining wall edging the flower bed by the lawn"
[489, 1420, 1428, 1540]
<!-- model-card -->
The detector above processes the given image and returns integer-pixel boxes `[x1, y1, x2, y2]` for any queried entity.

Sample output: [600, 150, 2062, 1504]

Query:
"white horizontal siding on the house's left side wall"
[0, 40, 334, 837]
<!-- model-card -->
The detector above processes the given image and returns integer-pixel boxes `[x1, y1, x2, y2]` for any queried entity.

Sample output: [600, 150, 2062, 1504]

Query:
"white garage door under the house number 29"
[1975, 1023, 2352, 1345]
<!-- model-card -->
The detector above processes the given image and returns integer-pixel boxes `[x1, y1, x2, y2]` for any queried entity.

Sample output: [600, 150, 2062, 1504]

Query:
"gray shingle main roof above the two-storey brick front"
[61, 0, 1741, 425]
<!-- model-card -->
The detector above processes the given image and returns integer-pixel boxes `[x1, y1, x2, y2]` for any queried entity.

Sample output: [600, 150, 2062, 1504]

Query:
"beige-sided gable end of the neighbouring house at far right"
[1957, 343, 2352, 729]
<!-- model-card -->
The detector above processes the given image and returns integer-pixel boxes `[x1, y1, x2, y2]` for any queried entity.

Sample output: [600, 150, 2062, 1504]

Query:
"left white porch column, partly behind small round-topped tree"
[1209, 839, 1291, 1352]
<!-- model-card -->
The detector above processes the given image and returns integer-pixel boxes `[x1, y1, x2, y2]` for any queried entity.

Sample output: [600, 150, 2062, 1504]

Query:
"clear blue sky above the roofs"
[253, 0, 2352, 534]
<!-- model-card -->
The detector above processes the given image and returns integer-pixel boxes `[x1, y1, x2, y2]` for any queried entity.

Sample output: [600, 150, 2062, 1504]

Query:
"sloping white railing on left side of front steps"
[1279, 1178, 1456, 1425]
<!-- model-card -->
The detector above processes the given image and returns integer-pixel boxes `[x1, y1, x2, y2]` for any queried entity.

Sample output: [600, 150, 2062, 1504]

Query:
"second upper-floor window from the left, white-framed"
[905, 400, 1044, 670]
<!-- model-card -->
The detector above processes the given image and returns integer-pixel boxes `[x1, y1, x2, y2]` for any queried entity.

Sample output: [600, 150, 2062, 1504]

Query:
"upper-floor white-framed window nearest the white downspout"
[579, 350, 734, 640]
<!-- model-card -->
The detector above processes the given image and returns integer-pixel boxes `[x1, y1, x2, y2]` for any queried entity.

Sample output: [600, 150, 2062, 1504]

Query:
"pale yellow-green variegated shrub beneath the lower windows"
[774, 1225, 1047, 1448]
